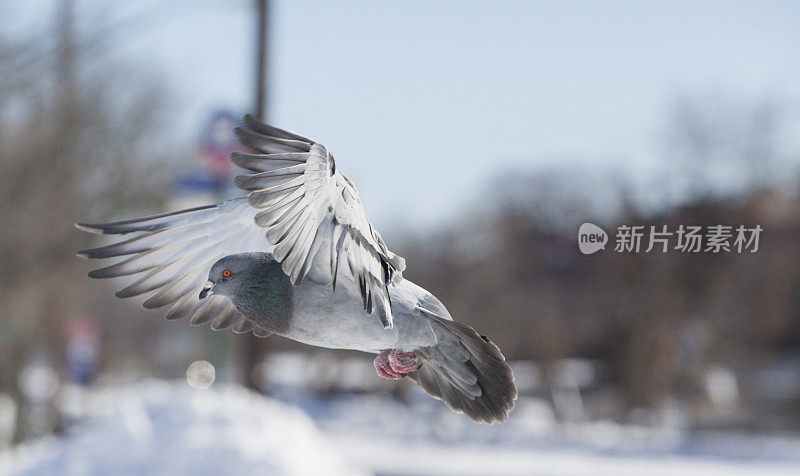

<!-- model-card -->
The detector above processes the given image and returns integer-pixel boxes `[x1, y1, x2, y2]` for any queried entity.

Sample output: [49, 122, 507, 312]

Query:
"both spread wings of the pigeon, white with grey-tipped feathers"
[77, 115, 405, 336]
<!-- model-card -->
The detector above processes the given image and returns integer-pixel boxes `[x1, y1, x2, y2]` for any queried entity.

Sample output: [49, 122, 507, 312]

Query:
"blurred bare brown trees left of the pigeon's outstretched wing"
[0, 1, 176, 438]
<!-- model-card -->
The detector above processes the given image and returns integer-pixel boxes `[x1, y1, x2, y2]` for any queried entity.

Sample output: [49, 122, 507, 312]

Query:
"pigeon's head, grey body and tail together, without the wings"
[204, 253, 516, 422]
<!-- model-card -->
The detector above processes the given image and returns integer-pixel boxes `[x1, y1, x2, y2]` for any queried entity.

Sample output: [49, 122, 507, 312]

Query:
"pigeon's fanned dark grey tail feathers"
[408, 313, 517, 423]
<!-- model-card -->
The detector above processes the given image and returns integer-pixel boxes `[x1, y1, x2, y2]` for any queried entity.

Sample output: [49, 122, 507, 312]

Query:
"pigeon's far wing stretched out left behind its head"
[76, 198, 272, 337]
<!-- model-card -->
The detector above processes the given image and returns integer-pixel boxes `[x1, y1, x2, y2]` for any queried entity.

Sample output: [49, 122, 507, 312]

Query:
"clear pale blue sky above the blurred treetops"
[6, 0, 800, 227]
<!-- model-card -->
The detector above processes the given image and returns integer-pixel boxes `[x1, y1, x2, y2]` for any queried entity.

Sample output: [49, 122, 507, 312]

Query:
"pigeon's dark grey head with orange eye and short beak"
[200, 253, 274, 299]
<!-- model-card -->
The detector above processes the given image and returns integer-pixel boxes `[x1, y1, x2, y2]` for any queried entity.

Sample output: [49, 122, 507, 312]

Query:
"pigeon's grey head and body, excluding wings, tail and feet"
[208, 253, 449, 353]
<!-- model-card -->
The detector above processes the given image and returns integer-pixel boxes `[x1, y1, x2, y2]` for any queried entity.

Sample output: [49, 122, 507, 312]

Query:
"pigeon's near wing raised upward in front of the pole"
[231, 115, 405, 328]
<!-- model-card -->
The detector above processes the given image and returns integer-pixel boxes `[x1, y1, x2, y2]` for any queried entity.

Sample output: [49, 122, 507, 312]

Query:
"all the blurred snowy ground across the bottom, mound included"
[0, 381, 800, 476]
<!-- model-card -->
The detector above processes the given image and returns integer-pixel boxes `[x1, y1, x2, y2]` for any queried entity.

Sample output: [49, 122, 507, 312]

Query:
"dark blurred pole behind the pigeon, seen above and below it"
[241, 0, 269, 391]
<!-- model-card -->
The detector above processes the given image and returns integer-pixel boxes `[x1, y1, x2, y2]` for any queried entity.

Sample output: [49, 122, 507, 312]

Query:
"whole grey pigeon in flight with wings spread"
[76, 115, 517, 423]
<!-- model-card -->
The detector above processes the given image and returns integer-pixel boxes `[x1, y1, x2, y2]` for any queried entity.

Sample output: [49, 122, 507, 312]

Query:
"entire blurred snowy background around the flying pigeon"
[0, 0, 800, 475]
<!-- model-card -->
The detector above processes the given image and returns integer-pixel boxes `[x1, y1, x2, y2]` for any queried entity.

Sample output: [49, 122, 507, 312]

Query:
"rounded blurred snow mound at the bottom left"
[0, 381, 368, 475]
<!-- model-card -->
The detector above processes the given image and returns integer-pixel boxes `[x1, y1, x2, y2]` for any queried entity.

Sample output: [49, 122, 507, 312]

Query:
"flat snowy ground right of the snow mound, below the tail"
[282, 392, 800, 476]
